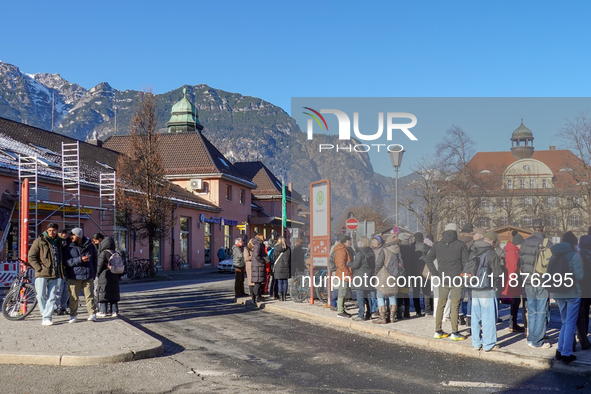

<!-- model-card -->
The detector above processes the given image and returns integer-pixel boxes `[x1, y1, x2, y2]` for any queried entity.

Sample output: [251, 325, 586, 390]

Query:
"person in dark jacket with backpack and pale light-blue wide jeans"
[464, 231, 503, 352]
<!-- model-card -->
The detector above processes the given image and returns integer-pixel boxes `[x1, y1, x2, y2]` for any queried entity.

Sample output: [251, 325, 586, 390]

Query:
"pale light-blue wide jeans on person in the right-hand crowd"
[471, 289, 498, 350]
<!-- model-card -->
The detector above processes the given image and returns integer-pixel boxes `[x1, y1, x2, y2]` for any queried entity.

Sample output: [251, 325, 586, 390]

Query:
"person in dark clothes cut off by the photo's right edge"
[577, 227, 591, 350]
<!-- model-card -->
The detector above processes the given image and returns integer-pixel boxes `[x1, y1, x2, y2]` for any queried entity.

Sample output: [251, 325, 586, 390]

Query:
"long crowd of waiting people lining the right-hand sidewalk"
[233, 219, 591, 364]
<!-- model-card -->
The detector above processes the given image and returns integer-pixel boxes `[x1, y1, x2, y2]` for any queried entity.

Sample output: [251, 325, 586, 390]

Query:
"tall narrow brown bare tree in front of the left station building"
[117, 92, 174, 267]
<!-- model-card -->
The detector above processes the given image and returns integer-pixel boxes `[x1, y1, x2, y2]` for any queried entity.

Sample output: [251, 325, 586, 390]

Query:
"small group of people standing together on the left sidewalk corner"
[27, 223, 121, 326]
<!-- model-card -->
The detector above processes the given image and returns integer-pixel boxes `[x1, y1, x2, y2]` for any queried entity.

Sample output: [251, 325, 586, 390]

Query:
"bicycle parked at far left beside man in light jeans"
[2, 260, 37, 320]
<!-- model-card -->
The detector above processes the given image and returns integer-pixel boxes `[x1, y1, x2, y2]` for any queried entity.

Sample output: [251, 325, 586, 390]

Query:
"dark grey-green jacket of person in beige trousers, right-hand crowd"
[425, 230, 468, 281]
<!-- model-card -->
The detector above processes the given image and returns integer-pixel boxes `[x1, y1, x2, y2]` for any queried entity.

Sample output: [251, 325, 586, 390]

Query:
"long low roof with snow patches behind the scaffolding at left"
[0, 117, 220, 211]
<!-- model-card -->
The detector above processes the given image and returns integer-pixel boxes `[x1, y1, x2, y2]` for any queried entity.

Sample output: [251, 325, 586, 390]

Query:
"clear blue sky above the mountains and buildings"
[0, 0, 591, 174]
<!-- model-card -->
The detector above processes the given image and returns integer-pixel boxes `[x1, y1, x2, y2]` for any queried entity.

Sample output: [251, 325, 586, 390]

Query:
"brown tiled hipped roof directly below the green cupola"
[104, 131, 255, 187]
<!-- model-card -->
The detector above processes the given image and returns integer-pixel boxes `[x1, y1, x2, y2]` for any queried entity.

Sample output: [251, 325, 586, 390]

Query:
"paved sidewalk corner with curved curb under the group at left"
[0, 308, 164, 366]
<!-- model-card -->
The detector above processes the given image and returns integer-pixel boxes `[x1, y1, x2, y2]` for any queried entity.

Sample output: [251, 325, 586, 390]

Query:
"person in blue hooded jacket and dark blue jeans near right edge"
[548, 231, 583, 365]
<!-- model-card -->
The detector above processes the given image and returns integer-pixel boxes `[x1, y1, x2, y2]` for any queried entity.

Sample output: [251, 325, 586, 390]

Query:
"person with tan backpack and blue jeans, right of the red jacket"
[519, 219, 552, 349]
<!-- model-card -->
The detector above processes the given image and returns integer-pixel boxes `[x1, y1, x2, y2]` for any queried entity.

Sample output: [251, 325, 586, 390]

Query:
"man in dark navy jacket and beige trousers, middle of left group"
[66, 227, 97, 323]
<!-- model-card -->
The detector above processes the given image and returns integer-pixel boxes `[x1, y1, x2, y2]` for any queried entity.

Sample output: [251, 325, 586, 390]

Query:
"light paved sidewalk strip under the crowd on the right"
[236, 298, 591, 373]
